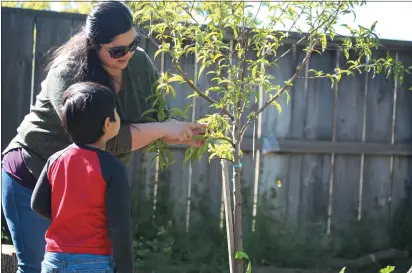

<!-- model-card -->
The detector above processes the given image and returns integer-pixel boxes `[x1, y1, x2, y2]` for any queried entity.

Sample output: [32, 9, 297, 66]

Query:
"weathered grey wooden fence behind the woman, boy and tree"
[1, 8, 412, 255]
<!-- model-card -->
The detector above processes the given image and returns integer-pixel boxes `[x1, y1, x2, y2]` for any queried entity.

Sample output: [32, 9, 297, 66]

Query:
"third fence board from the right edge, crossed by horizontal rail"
[331, 51, 365, 238]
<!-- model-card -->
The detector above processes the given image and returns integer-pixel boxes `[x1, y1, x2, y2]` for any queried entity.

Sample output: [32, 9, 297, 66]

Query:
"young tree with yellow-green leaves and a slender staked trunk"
[130, 1, 412, 273]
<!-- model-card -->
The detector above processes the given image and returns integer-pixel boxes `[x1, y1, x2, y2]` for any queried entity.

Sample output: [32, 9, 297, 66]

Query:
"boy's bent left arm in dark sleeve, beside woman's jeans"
[31, 161, 52, 221]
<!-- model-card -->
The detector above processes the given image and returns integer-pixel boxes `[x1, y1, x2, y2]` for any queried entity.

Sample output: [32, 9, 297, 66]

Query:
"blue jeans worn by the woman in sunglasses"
[1, 170, 50, 273]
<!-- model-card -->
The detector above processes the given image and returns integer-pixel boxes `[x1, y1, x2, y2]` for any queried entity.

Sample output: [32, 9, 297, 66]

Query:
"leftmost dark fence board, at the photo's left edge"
[1, 13, 34, 149]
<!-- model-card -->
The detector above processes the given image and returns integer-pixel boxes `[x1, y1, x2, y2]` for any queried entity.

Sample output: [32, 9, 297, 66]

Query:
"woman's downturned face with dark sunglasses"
[98, 28, 137, 70]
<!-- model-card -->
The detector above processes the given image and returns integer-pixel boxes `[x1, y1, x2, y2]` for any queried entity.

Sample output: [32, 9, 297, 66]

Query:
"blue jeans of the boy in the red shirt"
[41, 252, 114, 273]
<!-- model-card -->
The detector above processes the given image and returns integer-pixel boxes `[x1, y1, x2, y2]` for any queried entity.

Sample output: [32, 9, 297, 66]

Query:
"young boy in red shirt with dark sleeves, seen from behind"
[31, 82, 133, 273]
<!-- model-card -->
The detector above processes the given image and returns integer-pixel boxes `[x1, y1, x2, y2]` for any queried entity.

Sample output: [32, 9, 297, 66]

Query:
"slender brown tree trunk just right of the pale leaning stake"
[233, 119, 243, 273]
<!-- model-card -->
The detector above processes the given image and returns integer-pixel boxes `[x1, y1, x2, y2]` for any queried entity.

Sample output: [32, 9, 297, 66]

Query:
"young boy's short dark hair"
[62, 82, 116, 144]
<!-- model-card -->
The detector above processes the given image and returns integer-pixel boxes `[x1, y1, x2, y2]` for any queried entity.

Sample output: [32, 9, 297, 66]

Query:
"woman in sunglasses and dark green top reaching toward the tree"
[2, 1, 205, 273]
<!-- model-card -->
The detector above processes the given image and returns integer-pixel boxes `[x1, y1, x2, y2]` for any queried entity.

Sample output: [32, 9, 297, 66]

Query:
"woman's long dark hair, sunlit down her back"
[48, 1, 133, 88]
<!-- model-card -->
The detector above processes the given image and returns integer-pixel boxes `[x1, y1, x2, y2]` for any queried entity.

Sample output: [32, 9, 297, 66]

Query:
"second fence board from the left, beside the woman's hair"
[33, 17, 72, 96]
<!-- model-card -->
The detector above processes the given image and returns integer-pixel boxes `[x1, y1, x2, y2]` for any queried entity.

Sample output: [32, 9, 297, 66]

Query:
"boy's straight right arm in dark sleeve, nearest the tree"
[106, 163, 133, 273]
